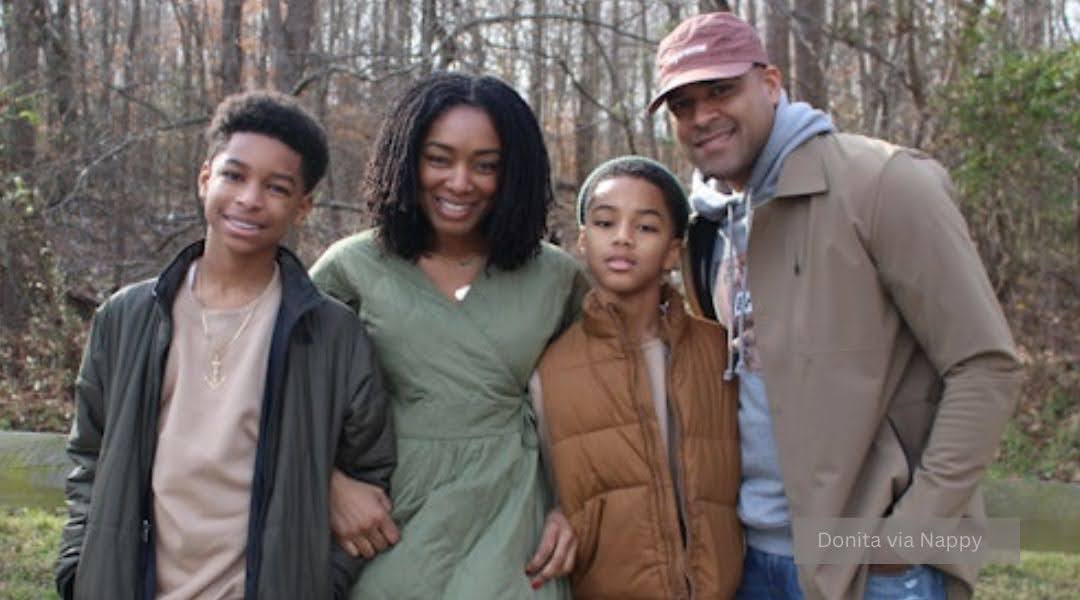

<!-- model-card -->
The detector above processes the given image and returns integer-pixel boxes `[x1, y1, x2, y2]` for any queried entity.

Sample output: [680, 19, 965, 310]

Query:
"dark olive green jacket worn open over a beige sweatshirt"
[56, 242, 395, 600]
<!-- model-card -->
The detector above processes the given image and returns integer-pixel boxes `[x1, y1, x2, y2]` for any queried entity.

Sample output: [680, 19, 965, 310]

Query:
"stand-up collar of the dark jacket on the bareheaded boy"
[153, 240, 323, 321]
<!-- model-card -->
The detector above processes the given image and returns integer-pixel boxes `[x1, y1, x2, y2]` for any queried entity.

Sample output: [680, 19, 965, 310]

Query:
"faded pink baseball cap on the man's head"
[648, 13, 769, 113]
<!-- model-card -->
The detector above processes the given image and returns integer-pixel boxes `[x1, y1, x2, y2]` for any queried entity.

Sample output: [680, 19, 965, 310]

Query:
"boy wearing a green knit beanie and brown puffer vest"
[532, 156, 743, 600]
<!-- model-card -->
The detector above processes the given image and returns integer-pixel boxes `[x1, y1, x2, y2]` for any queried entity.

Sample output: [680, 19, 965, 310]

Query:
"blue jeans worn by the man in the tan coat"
[735, 547, 945, 600]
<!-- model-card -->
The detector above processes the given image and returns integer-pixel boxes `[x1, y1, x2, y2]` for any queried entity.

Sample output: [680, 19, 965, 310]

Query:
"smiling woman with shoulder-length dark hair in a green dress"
[312, 73, 586, 600]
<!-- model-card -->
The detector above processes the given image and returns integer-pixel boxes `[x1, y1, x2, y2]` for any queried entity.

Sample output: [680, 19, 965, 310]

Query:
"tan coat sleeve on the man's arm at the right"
[869, 152, 1023, 517]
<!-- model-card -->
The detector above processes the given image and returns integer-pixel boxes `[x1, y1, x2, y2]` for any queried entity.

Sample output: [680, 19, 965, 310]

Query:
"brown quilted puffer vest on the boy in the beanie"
[539, 287, 743, 600]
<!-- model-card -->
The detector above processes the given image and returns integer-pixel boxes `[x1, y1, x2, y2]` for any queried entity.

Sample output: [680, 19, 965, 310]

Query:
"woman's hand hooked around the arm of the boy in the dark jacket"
[330, 468, 401, 559]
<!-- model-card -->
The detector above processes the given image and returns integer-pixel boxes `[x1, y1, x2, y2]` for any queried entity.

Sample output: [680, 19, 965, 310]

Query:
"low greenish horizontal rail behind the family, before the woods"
[0, 432, 1080, 554]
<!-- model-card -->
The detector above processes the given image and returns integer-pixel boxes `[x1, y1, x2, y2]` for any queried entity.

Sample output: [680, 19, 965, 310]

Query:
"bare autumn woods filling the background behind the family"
[0, 0, 1080, 482]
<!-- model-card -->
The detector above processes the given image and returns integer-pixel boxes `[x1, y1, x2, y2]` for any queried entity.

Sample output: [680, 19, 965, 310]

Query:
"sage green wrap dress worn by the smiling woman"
[311, 231, 588, 600]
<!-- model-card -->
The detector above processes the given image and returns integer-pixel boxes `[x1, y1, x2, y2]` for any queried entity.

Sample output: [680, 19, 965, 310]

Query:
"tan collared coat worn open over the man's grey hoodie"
[683, 134, 1022, 598]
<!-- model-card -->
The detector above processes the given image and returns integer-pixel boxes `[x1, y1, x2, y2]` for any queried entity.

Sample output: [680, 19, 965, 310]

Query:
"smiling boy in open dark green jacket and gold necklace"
[56, 92, 394, 599]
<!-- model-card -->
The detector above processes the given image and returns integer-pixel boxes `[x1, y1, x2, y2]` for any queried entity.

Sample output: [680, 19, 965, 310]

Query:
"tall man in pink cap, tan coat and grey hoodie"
[649, 13, 1022, 598]
